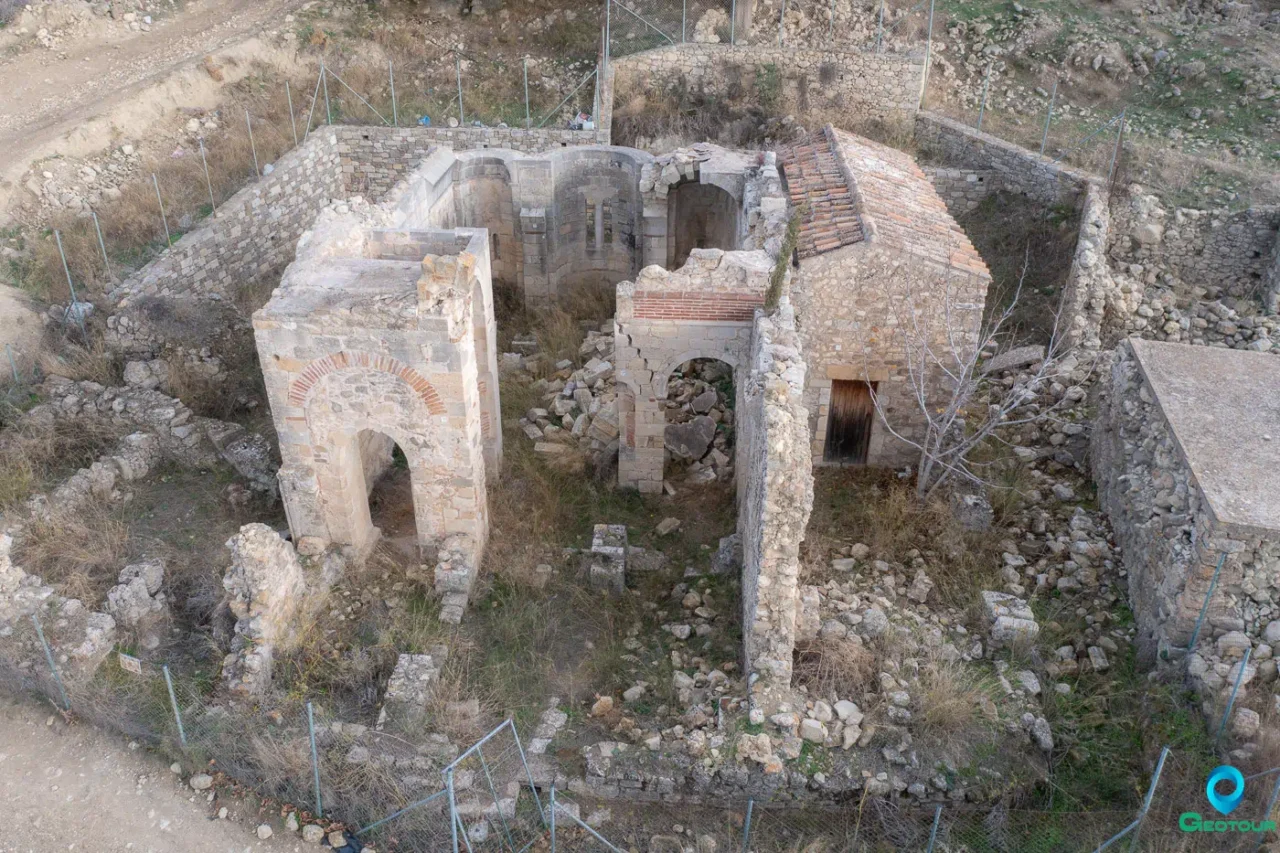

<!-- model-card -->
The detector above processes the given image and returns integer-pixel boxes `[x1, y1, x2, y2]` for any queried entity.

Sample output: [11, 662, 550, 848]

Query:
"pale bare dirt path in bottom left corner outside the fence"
[0, 698, 302, 853]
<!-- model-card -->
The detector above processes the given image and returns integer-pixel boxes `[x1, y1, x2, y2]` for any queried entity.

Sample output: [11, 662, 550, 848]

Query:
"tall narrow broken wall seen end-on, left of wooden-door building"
[737, 304, 813, 715]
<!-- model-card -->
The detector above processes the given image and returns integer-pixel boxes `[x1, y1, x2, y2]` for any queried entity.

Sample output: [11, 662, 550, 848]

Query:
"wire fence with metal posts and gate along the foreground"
[0, 617, 1280, 853]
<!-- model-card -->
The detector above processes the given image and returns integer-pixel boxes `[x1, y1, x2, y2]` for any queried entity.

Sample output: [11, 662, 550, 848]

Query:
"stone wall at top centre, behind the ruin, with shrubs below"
[613, 44, 924, 120]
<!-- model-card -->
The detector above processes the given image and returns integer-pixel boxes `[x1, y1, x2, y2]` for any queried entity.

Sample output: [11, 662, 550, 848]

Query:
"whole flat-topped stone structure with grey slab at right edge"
[1092, 339, 1280, 699]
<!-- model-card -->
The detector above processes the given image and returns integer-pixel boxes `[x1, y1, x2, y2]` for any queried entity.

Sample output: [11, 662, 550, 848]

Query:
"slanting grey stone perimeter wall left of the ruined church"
[110, 128, 344, 307]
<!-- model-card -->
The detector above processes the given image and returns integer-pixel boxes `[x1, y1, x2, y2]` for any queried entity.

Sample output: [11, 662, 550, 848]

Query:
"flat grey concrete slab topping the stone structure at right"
[1130, 339, 1280, 534]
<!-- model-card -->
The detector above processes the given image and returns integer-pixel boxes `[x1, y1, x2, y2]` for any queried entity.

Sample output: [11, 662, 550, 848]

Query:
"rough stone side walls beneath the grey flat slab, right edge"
[1091, 343, 1280, 694]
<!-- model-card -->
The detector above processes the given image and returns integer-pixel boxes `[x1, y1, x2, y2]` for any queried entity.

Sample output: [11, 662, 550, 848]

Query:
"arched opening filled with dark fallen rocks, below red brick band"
[660, 357, 737, 489]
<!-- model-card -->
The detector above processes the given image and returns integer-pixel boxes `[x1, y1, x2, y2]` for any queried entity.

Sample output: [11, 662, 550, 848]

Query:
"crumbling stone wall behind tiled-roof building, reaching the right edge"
[915, 110, 1280, 352]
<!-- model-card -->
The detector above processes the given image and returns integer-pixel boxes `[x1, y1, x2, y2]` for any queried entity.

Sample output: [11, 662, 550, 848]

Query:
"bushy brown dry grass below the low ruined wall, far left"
[14, 503, 136, 607]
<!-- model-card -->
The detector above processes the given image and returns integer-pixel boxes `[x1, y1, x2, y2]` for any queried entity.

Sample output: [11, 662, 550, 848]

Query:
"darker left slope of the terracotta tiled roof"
[781, 136, 863, 257]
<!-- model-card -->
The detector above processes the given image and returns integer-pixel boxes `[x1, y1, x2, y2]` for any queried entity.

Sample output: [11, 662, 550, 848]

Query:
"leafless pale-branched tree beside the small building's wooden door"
[868, 259, 1085, 500]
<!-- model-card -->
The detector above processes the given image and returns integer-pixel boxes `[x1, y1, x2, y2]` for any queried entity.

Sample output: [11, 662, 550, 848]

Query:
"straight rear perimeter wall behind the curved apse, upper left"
[333, 126, 609, 200]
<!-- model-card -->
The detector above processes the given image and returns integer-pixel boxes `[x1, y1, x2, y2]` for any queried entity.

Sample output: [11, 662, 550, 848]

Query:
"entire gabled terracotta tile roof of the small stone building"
[781, 126, 989, 277]
